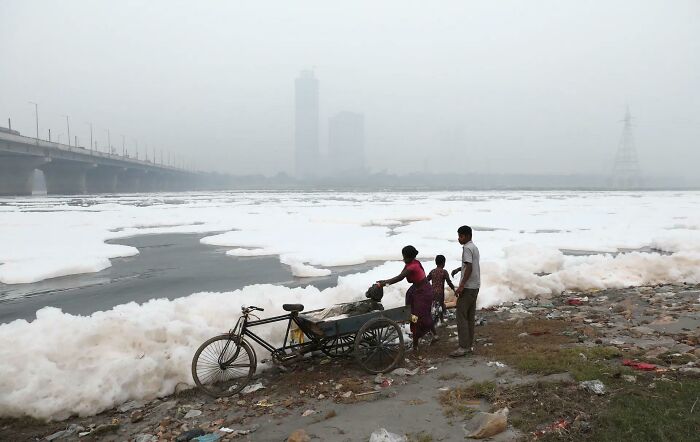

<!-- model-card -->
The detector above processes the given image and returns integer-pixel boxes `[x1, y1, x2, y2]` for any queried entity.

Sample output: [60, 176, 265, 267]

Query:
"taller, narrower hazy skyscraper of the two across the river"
[294, 70, 320, 179]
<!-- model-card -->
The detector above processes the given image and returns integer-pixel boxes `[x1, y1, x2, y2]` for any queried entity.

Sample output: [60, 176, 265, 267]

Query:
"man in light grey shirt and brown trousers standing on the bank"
[450, 226, 481, 357]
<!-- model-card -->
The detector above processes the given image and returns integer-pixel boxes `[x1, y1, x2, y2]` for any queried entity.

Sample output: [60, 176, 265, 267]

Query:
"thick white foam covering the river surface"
[0, 192, 700, 419]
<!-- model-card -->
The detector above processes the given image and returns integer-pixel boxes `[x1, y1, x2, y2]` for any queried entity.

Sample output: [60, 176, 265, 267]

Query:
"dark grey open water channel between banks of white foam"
[0, 234, 377, 323]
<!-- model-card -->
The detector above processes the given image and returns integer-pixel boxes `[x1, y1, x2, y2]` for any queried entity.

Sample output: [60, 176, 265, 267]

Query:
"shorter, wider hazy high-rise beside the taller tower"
[328, 112, 365, 176]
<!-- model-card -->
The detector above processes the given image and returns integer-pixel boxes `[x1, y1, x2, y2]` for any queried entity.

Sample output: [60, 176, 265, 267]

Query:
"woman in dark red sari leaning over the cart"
[377, 246, 437, 351]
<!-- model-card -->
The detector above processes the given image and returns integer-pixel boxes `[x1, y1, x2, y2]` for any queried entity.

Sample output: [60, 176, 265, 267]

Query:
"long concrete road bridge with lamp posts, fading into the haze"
[0, 131, 205, 195]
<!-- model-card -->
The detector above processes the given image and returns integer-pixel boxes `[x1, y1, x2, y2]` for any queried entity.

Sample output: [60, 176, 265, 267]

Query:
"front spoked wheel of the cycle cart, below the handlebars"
[192, 334, 257, 397]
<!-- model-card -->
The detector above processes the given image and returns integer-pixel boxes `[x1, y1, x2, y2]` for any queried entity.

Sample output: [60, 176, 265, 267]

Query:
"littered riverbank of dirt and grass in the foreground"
[0, 284, 700, 442]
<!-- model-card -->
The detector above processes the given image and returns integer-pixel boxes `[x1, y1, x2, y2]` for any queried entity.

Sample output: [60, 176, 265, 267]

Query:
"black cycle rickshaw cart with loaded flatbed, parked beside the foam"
[192, 295, 411, 397]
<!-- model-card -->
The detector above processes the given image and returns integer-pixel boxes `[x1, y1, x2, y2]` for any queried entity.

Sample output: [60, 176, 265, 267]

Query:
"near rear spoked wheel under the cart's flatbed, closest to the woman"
[355, 318, 404, 374]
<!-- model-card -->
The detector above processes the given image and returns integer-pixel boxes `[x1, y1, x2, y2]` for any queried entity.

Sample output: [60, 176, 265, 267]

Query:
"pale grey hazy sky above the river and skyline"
[0, 0, 700, 176]
